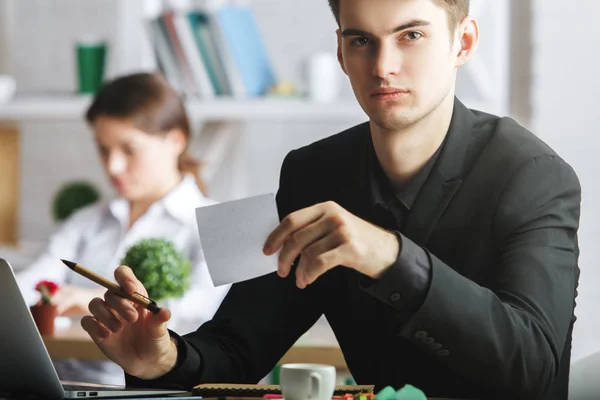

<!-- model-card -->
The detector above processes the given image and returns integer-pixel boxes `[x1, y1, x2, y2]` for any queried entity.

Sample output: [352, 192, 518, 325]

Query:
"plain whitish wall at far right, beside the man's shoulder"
[532, 0, 600, 359]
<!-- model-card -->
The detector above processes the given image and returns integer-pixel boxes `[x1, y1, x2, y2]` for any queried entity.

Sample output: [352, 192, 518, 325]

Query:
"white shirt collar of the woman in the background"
[108, 174, 215, 224]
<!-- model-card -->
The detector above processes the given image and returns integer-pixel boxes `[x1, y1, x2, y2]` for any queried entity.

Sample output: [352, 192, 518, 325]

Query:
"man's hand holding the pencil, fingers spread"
[81, 265, 177, 379]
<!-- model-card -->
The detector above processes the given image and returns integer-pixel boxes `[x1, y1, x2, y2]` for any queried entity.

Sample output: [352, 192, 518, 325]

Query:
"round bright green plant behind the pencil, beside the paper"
[121, 238, 191, 300]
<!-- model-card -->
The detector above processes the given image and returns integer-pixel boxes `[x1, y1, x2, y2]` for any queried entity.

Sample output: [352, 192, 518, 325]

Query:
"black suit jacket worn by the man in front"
[130, 101, 580, 399]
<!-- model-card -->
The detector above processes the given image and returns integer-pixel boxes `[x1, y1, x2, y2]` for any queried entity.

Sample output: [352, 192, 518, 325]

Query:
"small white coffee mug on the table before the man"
[279, 364, 335, 400]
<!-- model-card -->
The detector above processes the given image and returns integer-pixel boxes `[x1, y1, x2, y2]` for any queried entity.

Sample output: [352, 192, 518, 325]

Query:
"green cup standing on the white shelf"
[76, 37, 108, 94]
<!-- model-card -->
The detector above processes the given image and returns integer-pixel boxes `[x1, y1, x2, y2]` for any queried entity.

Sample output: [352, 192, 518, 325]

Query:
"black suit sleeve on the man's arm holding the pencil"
[126, 149, 323, 389]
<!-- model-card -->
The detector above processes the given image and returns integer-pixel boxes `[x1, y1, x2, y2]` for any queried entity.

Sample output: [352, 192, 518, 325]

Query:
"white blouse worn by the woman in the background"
[17, 175, 229, 333]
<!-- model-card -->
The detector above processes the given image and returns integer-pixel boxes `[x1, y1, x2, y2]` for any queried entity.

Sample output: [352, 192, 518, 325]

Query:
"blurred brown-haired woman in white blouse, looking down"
[17, 73, 229, 383]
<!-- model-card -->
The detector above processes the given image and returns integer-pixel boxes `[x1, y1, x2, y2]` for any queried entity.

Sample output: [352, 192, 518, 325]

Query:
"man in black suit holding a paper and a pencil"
[82, 0, 580, 399]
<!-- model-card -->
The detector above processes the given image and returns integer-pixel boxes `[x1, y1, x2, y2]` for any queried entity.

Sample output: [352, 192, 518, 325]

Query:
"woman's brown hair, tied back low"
[85, 72, 206, 197]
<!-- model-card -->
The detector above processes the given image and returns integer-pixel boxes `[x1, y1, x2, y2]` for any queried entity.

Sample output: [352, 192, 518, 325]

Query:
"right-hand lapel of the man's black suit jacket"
[404, 99, 473, 246]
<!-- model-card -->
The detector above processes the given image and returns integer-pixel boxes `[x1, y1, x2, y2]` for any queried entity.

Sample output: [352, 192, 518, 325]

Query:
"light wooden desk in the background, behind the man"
[44, 321, 348, 370]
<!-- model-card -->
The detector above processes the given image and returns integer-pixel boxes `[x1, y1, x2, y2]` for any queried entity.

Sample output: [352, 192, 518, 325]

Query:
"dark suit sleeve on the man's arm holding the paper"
[400, 156, 581, 398]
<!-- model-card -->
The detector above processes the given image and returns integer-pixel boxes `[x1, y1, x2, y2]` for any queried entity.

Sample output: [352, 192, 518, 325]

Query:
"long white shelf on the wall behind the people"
[0, 94, 367, 122]
